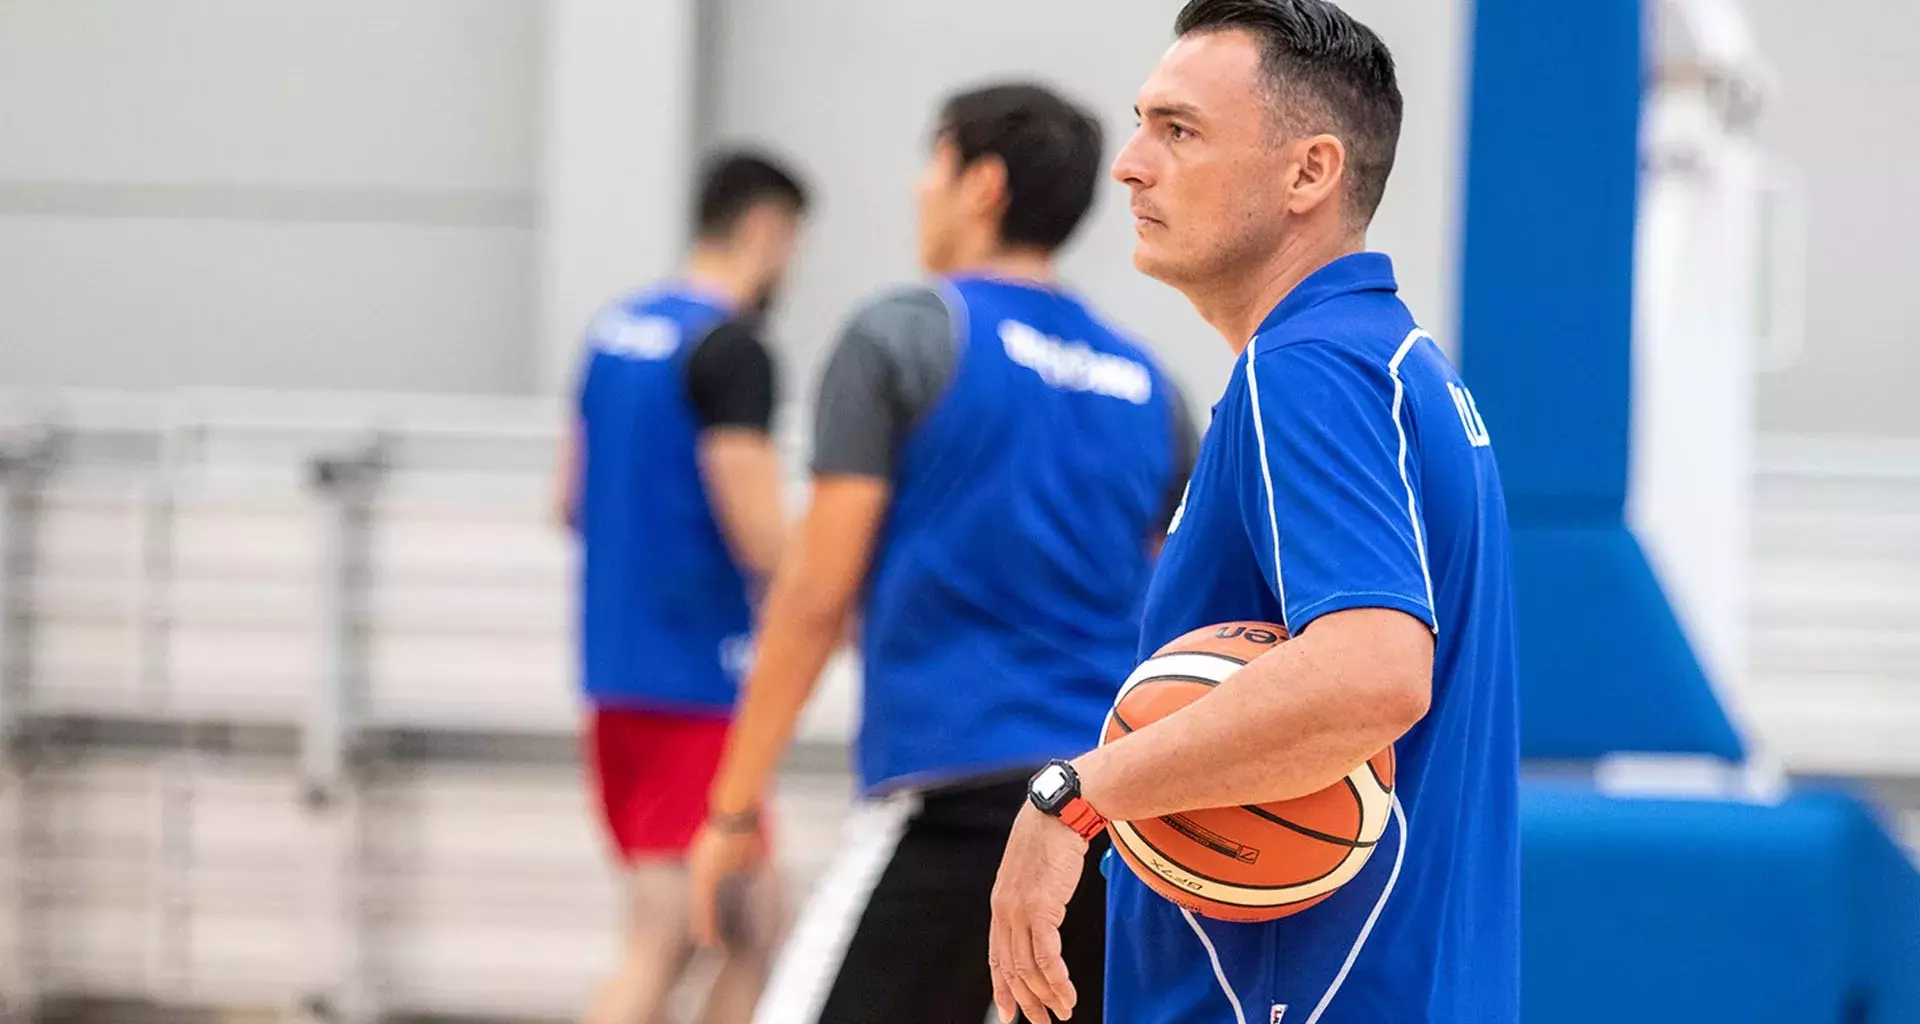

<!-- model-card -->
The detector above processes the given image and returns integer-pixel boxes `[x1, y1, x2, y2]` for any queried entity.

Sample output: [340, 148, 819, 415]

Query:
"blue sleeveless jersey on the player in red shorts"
[578, 288, 751, 715]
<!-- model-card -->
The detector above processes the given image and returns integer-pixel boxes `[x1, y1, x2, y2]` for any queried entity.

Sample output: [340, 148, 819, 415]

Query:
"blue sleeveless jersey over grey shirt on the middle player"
[858, 279, 1177, 793]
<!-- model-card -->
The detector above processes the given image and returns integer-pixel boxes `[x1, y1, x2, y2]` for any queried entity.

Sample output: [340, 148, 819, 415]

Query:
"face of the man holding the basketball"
[1114, 31, 1286, 286]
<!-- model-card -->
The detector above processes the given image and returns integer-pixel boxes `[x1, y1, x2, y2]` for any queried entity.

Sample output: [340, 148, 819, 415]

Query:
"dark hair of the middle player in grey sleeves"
[935, 83, 1104, 252]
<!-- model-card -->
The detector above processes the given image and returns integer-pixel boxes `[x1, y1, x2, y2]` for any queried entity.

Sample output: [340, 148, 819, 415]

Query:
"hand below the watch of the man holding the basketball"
[987, 803, 1087, 1024]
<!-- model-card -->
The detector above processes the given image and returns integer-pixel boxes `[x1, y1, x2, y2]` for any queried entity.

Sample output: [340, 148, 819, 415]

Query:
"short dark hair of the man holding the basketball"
[1173, 0, 1402, 225]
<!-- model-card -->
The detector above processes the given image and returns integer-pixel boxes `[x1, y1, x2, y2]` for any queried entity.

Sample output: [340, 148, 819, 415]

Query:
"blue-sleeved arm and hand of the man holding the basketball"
[993, 342, 1434, 1018]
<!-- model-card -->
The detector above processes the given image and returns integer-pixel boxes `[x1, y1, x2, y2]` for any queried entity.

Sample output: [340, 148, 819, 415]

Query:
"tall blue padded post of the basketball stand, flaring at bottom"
[1461, 0, 1741, 759]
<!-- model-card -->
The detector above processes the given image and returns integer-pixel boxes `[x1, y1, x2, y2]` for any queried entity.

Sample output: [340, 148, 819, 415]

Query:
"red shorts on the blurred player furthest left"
[586, 707, 728, 861]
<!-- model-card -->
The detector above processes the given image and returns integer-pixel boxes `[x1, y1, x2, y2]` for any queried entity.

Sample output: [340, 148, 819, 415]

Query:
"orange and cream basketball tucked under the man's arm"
[1100, 622, 1394, 922]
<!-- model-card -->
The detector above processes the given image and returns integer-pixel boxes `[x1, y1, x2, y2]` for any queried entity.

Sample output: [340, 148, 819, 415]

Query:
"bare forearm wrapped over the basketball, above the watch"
[1075, 613, 1430, 820]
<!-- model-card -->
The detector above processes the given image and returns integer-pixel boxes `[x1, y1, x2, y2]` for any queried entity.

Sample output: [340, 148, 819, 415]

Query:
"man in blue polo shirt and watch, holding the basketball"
[989, 0, 1519, 1024]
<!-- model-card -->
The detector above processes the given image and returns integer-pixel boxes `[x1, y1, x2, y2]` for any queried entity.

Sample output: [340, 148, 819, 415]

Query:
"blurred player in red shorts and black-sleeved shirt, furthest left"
[557, 152, 806, 1024]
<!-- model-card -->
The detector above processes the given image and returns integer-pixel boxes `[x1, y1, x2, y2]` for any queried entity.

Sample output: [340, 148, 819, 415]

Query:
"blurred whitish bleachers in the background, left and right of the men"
[0, 392, 1920, 1024]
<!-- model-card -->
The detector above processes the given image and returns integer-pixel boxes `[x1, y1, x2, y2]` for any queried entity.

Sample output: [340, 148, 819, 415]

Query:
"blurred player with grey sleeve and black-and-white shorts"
[693, 85, 1196, 1024]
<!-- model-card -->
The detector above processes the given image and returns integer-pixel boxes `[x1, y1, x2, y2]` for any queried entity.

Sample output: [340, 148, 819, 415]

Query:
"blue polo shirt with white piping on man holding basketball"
[1106, 254, 1519, 1024]
